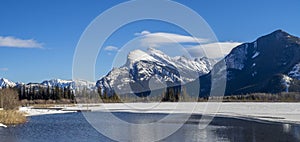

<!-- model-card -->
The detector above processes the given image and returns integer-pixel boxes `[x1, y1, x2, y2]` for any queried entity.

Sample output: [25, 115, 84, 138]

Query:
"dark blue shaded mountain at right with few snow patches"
[200, 30, 300, 96]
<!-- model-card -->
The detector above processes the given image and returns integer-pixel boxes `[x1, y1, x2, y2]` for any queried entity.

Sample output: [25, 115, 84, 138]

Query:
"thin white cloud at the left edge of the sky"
[0, 36, 43, 48]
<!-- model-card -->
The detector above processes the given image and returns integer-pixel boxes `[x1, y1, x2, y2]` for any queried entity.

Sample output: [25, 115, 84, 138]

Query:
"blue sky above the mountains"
[0, 0, 300, 82]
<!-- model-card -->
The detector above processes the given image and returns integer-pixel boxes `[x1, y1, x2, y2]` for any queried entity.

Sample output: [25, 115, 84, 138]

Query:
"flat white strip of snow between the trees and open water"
[20, 102, 300, 124]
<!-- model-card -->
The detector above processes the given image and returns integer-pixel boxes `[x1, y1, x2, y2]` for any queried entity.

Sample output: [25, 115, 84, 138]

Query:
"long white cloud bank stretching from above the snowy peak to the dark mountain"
[134, 31, 241, 58]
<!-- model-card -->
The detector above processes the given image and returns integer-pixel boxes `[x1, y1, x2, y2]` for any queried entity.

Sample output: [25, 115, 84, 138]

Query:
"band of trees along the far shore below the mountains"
[0, 85, 300, 105]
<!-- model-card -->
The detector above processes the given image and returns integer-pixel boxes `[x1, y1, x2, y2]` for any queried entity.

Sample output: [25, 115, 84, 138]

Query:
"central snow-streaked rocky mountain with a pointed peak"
[96, 48, 212, 93]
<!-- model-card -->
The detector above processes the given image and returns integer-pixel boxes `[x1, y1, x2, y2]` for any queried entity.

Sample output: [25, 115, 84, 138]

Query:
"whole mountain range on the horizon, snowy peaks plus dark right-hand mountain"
[0, 30, 300, 96]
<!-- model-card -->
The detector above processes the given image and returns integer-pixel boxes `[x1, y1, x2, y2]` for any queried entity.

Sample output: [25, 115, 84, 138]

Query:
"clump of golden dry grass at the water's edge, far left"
[0, 110, 26, 125]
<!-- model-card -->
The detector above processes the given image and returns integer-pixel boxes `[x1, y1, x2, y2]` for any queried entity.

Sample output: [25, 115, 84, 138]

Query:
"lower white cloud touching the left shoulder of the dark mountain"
[186, 42, 242, 58]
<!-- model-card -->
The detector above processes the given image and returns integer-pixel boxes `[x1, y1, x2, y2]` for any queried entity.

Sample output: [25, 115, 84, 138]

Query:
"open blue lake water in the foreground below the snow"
[0, 112, 300, 142]
